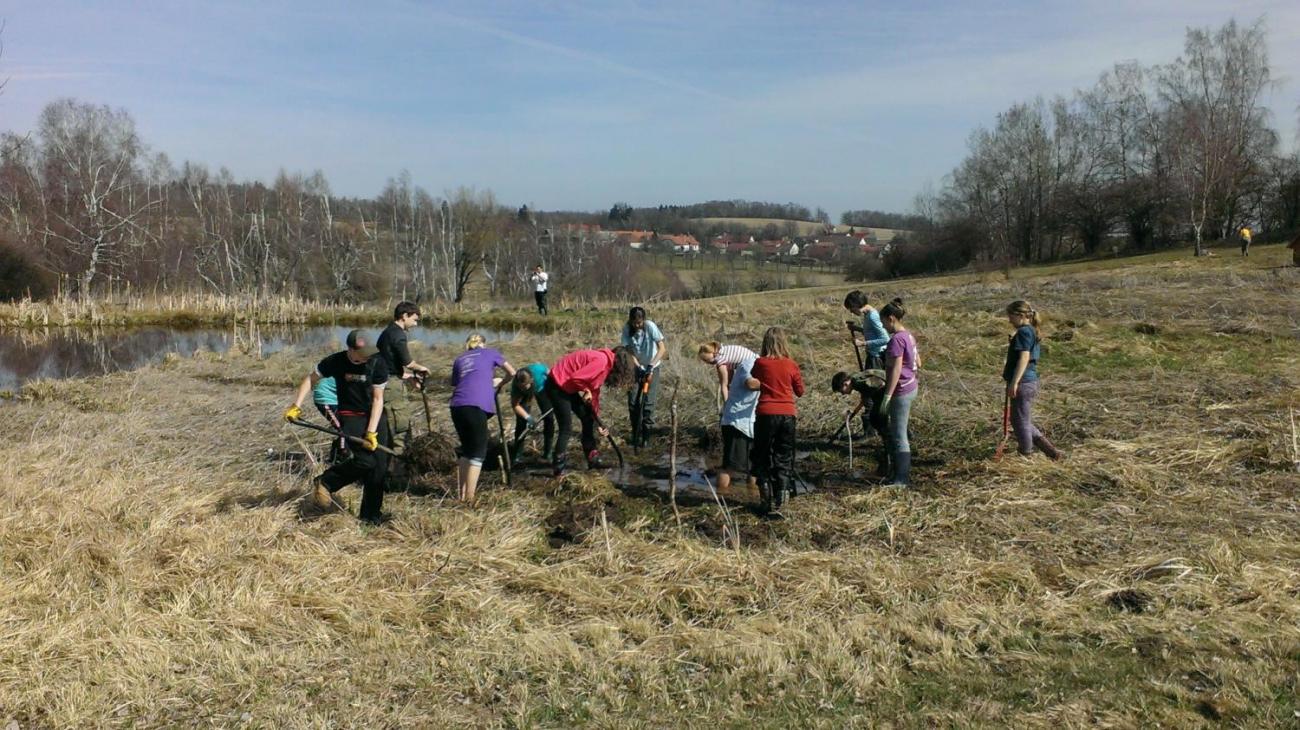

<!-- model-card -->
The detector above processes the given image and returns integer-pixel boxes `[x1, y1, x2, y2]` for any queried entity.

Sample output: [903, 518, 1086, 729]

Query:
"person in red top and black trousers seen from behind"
[745, 327, 803, 520]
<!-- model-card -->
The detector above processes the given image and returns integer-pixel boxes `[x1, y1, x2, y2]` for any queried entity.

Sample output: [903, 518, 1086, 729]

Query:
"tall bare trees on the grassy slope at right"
[875, 21, 1300, 275]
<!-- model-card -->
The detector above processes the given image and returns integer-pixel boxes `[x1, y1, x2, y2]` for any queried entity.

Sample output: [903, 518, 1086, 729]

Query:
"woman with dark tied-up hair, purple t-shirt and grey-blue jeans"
[878, 297, 920, 487]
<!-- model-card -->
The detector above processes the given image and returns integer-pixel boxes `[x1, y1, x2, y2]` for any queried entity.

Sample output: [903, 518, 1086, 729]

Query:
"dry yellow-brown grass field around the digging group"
[0, 247, 1300, 729]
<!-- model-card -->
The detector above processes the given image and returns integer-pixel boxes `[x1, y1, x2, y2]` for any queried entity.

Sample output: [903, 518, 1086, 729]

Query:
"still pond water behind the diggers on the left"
[0, 326, 512, 391]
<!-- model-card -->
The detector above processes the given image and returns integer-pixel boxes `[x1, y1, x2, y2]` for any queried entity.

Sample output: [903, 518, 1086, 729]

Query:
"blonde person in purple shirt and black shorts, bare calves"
[449, 334, 515, 503]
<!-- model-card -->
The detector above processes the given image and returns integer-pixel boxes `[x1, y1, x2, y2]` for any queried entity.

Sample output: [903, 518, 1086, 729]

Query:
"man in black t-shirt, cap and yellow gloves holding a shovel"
[285, 330, 389, 525]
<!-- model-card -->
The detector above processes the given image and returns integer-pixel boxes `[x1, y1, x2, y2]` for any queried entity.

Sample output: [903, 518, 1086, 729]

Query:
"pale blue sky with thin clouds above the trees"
[0, 0, 1300, 217]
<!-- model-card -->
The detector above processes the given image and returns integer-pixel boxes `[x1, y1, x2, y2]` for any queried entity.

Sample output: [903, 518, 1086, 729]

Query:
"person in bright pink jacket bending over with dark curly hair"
[545, 347, 637, 477]
